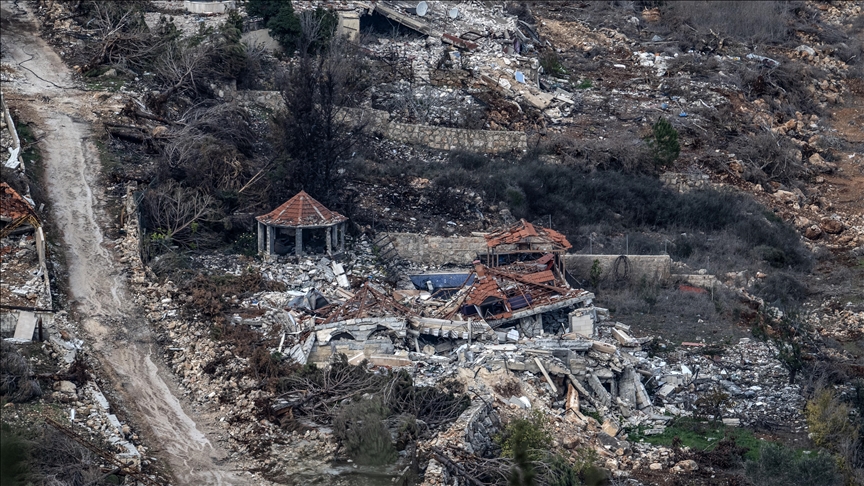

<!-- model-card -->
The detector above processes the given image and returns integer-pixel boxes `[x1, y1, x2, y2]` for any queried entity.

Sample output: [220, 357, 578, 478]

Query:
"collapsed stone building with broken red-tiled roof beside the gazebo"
[253, 220, 666, 426]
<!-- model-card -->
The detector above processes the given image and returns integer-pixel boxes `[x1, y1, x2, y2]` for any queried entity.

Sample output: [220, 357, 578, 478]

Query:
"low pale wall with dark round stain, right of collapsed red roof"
[564, 255, 672, 282]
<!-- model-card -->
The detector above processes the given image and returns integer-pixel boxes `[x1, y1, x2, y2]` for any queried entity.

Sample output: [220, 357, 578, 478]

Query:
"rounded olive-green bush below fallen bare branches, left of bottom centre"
[333, 398, 397, 466]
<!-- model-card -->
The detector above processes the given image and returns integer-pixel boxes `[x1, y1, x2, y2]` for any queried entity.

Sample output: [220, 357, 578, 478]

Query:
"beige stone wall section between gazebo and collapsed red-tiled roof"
[388, 233, 486, 265]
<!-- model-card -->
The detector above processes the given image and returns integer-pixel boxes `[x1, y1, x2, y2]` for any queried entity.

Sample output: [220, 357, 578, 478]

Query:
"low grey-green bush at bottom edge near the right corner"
[745, 442, 843, 486]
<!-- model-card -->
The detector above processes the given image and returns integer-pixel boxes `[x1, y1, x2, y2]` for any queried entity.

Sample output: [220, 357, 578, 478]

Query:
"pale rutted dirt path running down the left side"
[0, 1, 250, 485]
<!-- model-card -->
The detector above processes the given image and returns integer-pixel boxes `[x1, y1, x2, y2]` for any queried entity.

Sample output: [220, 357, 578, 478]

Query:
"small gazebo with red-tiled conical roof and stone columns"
[255, 191, 348, 257]
